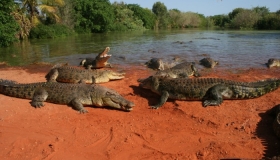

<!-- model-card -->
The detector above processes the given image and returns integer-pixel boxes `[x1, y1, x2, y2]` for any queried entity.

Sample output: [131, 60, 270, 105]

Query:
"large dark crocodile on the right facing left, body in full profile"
[138, 76, 280, 109]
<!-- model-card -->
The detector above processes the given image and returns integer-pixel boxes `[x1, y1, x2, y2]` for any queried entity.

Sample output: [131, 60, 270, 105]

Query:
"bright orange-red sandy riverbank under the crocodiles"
[0, 65, 280, 160]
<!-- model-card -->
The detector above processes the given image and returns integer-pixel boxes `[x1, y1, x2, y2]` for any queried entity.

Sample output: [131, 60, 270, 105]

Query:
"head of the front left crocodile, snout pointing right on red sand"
[97, 89, 135, 111]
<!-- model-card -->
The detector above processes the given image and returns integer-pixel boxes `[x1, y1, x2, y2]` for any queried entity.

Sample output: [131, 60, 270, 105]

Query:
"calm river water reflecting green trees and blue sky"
[0, 30, 280, 68]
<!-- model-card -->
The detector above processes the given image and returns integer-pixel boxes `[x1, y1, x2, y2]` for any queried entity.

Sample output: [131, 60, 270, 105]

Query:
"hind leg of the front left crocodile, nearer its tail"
[30, 88, 48, 108]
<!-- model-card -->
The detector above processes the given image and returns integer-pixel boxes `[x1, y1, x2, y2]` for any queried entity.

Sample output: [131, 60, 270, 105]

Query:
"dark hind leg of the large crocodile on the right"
[202, 84, 232, 107]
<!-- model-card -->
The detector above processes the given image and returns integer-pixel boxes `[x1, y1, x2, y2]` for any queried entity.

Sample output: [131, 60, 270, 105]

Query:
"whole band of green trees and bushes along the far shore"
[0, 0, 280, 47]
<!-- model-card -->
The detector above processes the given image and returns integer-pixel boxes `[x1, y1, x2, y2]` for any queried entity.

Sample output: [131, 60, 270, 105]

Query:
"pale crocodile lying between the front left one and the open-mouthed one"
[45, 65, 125, 83]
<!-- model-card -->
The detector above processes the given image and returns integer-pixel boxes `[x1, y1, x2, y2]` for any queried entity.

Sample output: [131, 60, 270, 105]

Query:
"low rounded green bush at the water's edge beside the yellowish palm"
[29, 24, 74, 39]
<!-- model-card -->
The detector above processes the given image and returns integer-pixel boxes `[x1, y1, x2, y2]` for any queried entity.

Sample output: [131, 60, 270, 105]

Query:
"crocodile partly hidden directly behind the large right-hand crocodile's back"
[154, 62, 200, 78]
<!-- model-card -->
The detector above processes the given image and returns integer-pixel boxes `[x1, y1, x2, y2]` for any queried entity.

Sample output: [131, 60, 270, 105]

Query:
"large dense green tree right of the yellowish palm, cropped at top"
[73, 0, 115, 32]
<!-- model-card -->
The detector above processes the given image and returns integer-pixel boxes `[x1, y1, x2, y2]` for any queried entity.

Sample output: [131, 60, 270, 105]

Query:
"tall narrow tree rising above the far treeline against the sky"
[152, 2, 169, 28]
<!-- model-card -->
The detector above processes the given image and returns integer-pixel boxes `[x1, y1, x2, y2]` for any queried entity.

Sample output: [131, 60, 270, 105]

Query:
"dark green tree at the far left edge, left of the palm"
[0, 0, 19, 47]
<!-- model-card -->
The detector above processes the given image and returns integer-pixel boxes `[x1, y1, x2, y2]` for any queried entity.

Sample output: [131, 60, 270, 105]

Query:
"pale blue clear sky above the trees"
[110, 0, 280, 16]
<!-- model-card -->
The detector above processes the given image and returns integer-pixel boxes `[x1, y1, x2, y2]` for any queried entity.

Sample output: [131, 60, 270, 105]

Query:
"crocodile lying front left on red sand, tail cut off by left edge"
[0, 79, 135, 113]
